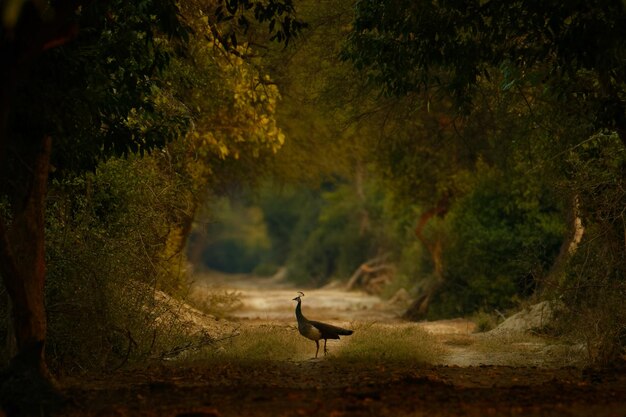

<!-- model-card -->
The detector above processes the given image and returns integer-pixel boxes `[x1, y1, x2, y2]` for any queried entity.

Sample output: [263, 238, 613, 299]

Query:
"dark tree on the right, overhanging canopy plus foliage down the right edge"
[343, 0, 626, 358]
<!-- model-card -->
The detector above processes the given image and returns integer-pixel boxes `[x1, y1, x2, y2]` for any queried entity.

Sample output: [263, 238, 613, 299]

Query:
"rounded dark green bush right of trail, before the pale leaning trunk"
[432, 164, 565, 315]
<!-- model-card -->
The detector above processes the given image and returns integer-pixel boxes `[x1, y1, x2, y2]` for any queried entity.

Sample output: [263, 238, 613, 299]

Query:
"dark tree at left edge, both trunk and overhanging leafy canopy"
[0, 0, 302, 412]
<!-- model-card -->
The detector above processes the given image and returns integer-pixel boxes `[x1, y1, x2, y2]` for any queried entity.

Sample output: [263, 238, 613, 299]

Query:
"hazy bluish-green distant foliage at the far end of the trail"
[195, 184, 374, 286]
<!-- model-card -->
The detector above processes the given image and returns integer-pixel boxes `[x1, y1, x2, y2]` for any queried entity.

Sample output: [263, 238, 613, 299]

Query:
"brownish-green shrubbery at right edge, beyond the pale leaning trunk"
[559, 134, 626, 365]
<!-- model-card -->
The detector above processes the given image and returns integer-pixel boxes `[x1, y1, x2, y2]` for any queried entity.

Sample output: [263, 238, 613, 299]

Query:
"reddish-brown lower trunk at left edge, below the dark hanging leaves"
[0, 137, 63, 416]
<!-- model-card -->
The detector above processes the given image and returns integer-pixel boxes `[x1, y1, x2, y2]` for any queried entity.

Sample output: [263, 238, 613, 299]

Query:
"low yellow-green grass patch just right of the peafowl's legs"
[333, 324, 445, 363]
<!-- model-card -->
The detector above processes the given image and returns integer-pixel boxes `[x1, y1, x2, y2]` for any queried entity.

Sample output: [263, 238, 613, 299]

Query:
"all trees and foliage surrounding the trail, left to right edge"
[0, 0, 626, 390]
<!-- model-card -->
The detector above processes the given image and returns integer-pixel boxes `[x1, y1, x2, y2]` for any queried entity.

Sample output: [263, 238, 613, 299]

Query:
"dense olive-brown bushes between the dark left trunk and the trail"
[46, 157, 193, 371]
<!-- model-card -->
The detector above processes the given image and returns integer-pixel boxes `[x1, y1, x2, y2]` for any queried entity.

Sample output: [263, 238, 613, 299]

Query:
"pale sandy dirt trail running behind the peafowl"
[195, 273, 572, 367]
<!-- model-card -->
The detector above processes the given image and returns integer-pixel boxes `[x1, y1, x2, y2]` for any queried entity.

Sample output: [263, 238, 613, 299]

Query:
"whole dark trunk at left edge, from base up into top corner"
[0, 0, 83, 416]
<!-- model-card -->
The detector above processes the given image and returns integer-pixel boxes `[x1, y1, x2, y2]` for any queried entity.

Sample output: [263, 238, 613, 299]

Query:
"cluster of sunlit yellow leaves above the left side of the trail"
[156, 4, 285, 200]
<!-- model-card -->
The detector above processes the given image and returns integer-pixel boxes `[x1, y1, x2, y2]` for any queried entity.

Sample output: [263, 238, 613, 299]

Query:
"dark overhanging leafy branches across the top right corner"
[344, 0, 626, 143]
